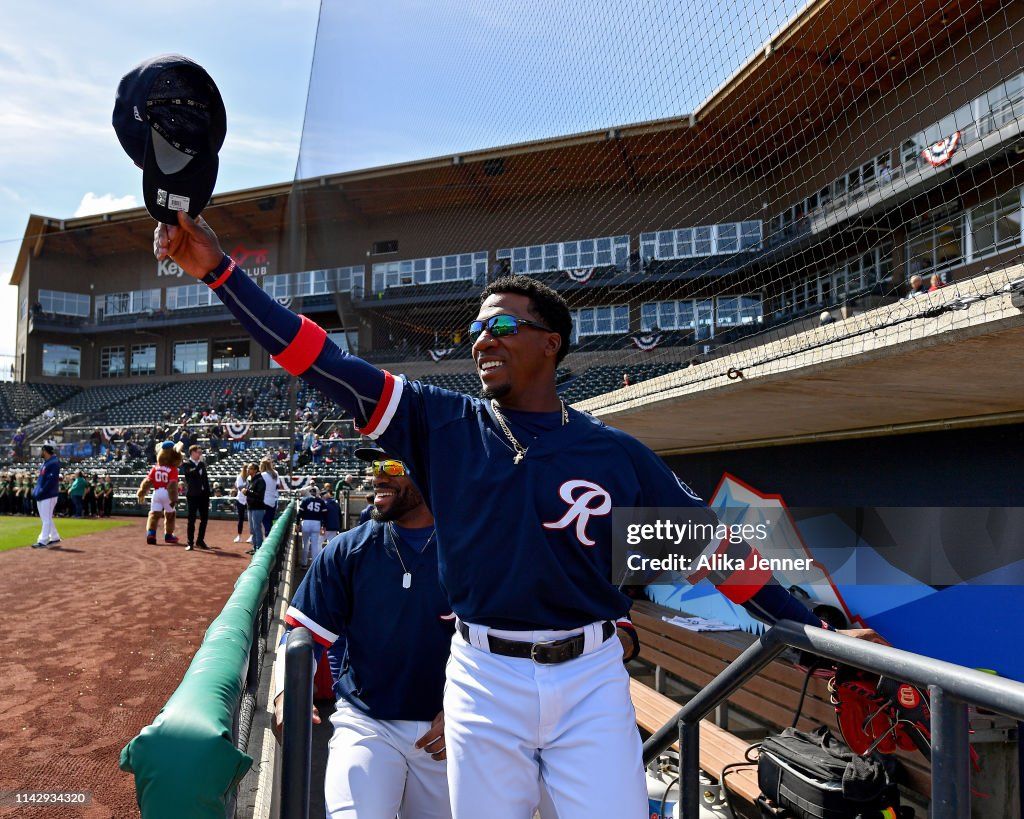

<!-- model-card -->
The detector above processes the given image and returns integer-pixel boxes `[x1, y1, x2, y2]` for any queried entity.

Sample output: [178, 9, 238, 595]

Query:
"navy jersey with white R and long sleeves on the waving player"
[204, 257, 820, 630]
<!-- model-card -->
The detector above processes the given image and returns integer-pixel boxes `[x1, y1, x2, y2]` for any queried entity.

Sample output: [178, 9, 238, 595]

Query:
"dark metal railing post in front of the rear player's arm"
[281, 628, 313, 819]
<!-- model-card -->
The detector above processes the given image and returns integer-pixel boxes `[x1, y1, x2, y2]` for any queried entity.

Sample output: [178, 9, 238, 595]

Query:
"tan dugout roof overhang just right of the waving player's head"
[577, 265, 1024, 455]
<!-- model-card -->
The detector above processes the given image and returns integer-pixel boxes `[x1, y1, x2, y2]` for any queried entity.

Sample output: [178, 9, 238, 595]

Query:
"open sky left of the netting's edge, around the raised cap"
[0, 0, 319, 354]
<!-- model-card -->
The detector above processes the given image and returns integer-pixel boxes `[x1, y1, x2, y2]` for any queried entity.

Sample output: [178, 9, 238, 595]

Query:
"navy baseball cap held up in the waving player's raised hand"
[112, 54, 227, 224]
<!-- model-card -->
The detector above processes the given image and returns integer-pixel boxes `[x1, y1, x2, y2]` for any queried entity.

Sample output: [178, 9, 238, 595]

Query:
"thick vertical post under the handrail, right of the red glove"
[928, 685, 971, 819]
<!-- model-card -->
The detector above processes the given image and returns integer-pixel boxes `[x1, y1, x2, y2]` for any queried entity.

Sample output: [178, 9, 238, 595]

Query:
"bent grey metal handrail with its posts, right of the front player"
[643, 620, 1024, 819]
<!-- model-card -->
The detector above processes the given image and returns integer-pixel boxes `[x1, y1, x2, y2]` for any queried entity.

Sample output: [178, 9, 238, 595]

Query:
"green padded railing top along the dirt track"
[121, 503, 295, 819]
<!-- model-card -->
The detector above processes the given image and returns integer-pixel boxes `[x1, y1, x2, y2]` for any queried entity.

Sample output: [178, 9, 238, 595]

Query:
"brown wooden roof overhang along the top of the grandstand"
[10, 0, 1010, 285]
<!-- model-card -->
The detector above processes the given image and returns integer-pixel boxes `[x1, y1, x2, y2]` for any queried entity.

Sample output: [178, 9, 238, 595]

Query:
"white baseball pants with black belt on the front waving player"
[444, 623, 647, 819]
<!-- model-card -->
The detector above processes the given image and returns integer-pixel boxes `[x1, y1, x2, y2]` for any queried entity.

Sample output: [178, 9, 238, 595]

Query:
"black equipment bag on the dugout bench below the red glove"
[758, 726, 900, 819]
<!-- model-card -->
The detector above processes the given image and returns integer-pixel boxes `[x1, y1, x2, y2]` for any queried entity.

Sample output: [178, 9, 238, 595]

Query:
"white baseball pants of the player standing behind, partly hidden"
[324, 699, 452, 819]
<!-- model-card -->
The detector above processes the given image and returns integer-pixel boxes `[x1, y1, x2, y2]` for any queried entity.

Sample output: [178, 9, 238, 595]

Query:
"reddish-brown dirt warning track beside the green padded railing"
[0, 518, 258, 819]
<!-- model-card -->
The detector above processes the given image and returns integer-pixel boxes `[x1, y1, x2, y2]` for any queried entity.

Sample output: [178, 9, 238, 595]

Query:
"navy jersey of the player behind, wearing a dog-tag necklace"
[285, 521, 455, 722]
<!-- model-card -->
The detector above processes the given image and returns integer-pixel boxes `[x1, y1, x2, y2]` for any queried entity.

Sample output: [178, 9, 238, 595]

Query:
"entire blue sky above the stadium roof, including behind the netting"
[0, 0, 799, 354]
